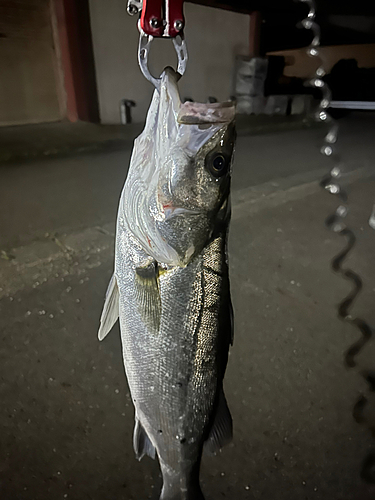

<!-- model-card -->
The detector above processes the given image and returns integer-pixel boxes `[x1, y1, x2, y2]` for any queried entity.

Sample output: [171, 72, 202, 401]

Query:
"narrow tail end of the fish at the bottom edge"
[159, 458, 205, 500]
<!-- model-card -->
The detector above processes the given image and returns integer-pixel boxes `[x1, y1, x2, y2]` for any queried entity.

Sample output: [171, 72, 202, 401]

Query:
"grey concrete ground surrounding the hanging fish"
[0, 115, 375, 500]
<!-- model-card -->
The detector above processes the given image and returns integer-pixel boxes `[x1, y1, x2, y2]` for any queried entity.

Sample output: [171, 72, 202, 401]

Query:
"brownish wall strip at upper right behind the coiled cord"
[268, 44, 375, 78]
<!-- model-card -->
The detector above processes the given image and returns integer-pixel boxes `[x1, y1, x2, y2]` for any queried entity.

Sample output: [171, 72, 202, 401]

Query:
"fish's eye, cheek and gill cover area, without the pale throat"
[155, 122, 236, 265]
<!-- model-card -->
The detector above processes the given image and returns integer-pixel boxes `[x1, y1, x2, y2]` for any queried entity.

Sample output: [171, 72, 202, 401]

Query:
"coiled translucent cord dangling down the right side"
[298, 0, 375, 483]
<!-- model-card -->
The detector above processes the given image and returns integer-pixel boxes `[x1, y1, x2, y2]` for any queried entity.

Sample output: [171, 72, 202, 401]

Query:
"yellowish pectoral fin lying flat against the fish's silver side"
[135, 261, 161, 334]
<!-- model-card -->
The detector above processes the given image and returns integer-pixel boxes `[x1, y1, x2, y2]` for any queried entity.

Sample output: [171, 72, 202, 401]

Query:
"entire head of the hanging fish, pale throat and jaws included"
[123, 68, 236, 266]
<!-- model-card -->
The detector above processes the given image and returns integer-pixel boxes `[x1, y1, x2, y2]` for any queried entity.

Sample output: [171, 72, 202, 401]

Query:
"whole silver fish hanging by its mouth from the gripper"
[98, 68, 236, 500]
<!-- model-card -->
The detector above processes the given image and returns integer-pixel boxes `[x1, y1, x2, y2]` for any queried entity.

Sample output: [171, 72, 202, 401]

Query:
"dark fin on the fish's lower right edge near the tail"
[204, 389, 233, 455]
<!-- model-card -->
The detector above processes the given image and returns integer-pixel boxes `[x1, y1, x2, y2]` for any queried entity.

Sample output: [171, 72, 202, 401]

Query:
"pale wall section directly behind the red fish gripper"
[90, 0, 249, 123]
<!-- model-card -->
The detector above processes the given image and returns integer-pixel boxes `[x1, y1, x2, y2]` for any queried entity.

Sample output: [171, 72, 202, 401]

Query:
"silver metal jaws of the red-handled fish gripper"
[138, 31, 188, 91]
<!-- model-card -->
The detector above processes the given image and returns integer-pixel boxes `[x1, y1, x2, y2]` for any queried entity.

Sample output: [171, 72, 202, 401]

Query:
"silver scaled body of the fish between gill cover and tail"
[116, 219, 230, 465]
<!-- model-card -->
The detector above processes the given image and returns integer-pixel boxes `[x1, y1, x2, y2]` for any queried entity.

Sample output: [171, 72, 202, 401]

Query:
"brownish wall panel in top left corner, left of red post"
[0, 0, 62, 125]
